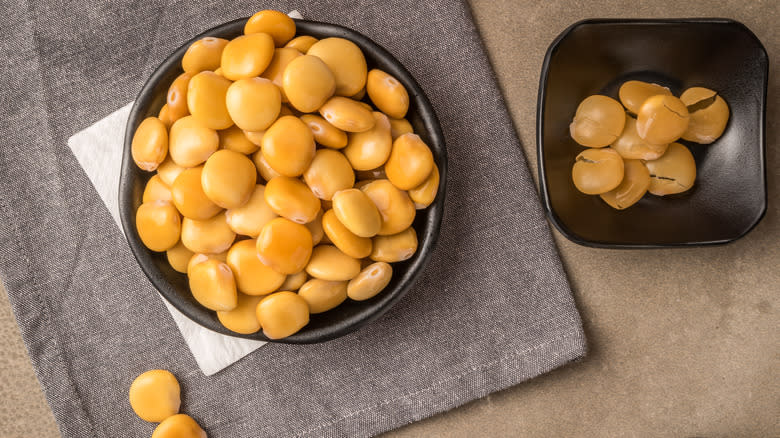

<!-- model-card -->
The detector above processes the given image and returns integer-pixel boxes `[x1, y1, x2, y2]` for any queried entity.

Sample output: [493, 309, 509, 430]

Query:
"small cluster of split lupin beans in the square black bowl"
[569, 81, 729, 210]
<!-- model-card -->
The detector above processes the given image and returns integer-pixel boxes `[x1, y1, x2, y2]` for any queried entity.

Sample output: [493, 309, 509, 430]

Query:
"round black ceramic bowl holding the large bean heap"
[119, 19, 447, 344]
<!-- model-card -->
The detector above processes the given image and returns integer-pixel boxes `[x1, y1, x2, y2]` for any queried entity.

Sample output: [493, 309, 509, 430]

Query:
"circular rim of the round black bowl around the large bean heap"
[119, 17, 447, 344]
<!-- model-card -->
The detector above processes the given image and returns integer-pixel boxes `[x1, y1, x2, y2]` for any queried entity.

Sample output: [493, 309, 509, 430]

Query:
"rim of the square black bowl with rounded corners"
[536, 18, 769, 249]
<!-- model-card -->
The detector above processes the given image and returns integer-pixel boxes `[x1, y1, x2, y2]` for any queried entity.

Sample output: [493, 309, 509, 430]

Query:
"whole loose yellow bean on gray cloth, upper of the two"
[128, 370, 181, 423]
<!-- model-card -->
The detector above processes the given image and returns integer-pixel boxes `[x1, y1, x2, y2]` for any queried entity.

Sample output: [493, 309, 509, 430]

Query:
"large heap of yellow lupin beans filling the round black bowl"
[132, 10, 439, 339]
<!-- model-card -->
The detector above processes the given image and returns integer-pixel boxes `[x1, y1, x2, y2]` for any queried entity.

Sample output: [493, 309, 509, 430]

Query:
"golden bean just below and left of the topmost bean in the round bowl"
[221, 33, 274, 81]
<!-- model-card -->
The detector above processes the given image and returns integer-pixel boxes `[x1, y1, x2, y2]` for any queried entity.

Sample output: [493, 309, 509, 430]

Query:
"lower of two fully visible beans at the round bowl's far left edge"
[135, 201, 182, 252]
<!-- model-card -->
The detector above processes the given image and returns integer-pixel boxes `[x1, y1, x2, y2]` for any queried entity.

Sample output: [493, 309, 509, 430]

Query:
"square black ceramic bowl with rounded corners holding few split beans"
[537, 19, 769, 248]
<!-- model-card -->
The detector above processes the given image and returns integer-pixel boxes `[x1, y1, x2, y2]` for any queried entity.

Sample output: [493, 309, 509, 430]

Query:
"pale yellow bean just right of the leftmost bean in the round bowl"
[168, 116, 219, 167]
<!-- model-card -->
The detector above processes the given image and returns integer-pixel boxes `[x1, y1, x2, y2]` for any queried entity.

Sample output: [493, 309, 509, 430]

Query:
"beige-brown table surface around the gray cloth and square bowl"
[0, 0, 780, 438]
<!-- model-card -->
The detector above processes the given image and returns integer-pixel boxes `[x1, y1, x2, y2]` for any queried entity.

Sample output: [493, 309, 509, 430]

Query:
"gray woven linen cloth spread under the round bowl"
[0, 0, 585, 437]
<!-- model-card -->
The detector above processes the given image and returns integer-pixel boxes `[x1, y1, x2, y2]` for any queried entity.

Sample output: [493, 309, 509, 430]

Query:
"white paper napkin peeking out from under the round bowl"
[68, 11, 303, 376]
